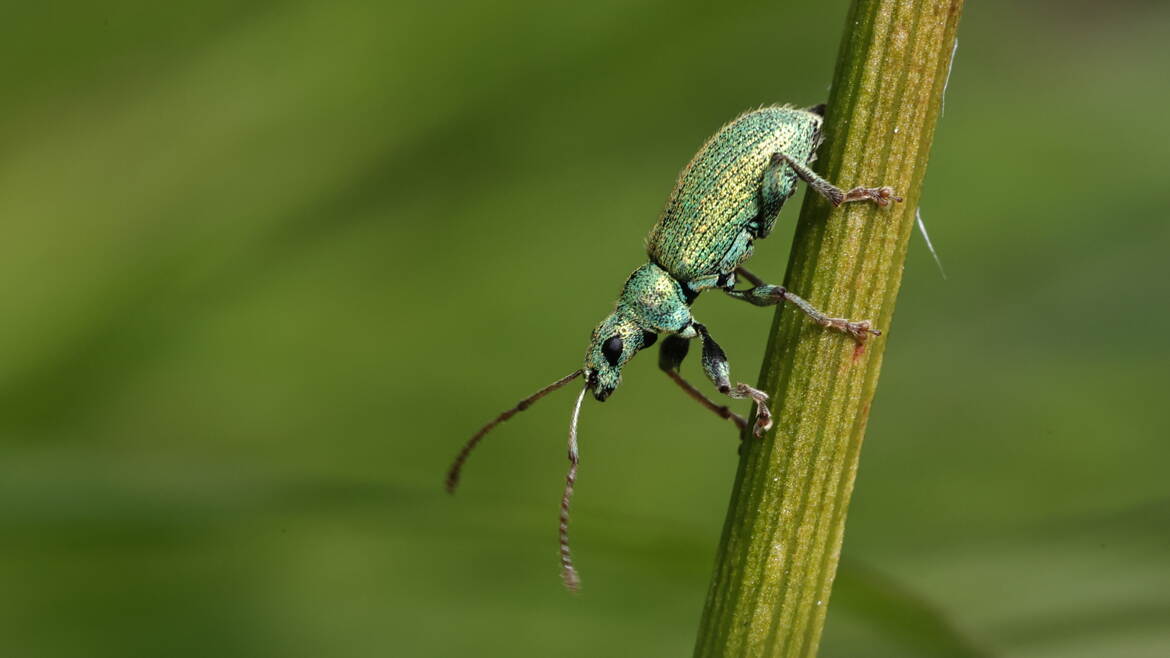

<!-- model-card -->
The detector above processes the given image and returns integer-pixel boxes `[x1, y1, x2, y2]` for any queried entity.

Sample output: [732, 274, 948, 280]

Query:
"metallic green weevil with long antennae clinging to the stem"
[447, 105, 902, 590]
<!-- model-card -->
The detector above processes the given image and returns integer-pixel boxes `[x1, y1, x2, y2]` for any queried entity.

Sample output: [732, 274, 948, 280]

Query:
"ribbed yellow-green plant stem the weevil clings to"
[695, 0, 963, 656]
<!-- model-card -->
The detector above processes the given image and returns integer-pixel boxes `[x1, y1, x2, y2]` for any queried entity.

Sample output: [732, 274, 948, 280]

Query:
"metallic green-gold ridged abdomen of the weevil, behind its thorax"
[646, 107, 820, 282]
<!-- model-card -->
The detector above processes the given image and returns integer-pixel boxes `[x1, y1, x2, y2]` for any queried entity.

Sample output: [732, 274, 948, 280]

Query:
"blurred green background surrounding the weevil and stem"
[0, 0, 1170, 657]
